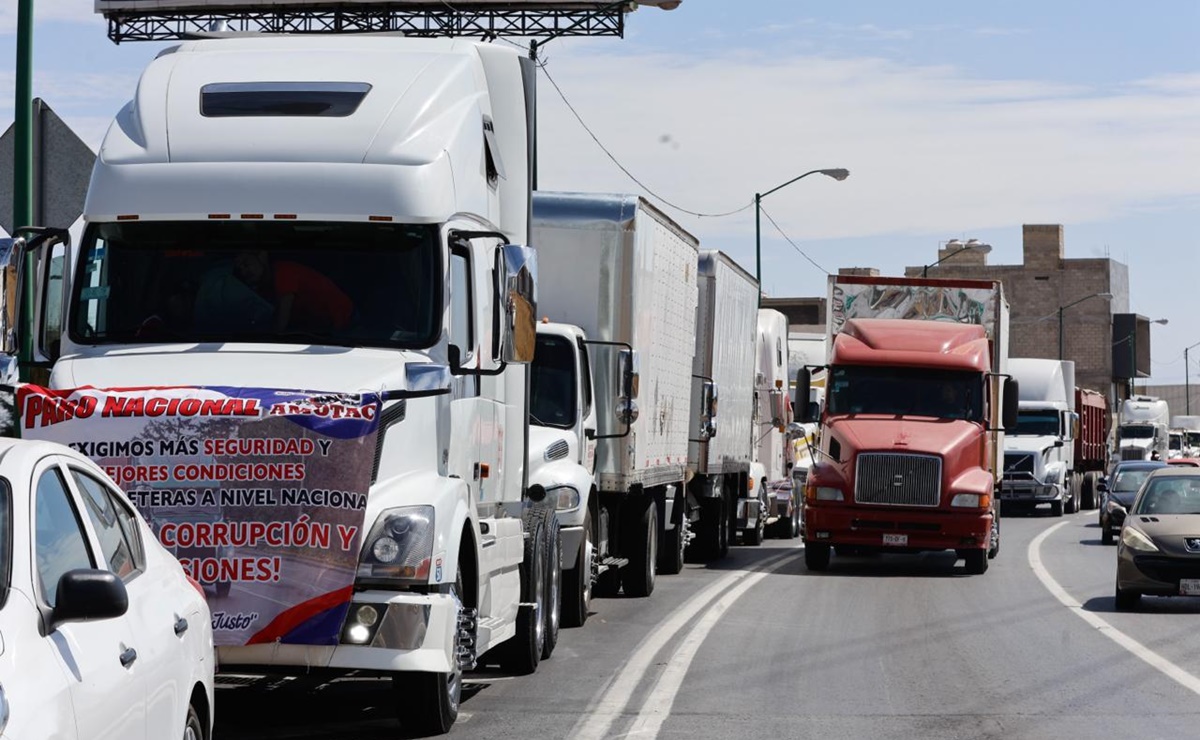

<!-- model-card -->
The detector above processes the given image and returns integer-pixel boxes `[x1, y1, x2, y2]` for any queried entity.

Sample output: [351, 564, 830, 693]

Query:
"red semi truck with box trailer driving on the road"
[796, 276, 1018, 573]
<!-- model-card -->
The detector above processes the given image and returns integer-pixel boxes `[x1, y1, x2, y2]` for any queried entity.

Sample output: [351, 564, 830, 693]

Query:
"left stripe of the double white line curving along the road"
[570, 547, 804, 740]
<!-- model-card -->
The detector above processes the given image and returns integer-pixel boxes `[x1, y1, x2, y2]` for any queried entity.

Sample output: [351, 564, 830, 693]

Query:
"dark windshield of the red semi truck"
[827, 366, 983, 421]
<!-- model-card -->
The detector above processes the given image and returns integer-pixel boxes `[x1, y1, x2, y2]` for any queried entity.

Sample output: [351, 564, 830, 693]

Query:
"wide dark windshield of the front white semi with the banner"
[70, 221, 443, 348]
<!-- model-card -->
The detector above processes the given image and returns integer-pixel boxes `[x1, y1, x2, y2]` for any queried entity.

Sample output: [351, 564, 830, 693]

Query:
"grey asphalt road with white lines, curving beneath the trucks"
[216, 511, 1200, 740]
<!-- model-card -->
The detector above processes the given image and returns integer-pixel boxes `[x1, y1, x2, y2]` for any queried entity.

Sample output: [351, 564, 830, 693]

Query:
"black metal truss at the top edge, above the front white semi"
[97, 0, 652, 43]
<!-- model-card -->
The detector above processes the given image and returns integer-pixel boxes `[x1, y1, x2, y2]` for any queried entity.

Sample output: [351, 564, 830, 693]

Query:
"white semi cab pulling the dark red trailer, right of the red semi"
[1001, 357, 1082, 517]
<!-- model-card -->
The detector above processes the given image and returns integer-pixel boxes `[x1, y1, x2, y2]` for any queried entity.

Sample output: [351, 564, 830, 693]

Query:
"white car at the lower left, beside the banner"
[0, 439, 214, 740]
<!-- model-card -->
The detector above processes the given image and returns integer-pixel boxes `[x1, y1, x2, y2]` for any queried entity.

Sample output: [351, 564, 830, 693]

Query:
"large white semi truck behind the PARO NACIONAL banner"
[6, 36, 559, 733]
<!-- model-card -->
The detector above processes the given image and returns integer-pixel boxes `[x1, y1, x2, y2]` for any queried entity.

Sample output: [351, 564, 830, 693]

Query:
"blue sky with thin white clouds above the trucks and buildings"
[0, 5, 1200, 383]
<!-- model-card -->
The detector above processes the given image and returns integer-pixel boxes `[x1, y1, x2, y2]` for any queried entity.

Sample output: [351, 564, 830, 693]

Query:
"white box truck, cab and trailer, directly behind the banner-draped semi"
[530, 193, 698, 611]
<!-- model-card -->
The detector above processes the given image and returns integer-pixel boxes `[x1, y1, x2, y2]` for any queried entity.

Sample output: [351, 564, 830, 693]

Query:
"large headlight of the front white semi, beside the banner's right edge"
[358, 506, 434, 583]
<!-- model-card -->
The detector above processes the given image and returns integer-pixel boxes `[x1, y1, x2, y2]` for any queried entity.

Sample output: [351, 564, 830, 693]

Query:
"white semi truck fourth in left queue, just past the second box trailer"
[746, 308, 800, 545]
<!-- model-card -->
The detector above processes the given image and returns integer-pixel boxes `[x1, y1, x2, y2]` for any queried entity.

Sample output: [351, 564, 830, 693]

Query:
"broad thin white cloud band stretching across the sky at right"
[539, 52, 1200, 245]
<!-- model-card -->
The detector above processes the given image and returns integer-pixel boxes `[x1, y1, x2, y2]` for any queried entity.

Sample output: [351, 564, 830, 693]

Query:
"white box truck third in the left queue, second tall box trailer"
[688, 249, 762, 558]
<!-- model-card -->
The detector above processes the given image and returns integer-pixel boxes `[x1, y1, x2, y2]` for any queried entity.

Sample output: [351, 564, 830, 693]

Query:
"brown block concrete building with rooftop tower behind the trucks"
[905, 224, 1129, 401]
